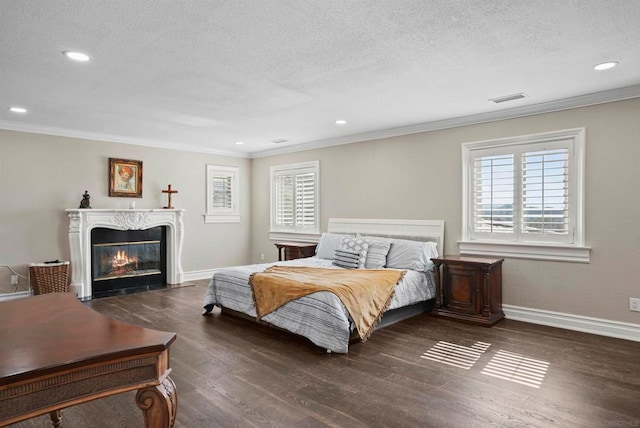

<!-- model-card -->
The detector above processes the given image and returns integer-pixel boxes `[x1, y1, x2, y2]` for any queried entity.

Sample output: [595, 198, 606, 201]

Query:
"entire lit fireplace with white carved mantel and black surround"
[66, 209, 184, 300]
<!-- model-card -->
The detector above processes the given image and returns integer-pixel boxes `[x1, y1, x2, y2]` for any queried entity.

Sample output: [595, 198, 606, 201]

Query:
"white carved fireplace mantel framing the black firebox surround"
[65, 209, 185, 299]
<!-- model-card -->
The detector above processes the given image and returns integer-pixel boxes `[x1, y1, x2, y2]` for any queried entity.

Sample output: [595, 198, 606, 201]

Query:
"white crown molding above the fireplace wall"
[0, 120, 249, 158]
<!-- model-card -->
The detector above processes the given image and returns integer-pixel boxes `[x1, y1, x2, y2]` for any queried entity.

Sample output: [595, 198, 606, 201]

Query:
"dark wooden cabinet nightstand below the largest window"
[431, 256, 504, 327]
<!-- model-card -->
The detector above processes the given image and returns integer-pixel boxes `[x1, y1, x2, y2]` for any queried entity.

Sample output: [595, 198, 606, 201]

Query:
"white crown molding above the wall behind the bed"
[250, 85, 640, 158]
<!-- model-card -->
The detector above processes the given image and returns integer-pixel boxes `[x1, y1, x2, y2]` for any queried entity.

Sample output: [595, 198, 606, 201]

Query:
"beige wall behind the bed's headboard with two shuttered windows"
[251, 99, 640, 324]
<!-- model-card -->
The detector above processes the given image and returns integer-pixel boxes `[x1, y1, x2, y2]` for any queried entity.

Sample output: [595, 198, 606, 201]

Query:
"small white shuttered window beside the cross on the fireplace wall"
[204, 165, 240, 223]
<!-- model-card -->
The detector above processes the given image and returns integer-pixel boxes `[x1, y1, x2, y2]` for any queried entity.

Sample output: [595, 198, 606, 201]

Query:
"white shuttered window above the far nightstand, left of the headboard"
[270, 161, 320, 240]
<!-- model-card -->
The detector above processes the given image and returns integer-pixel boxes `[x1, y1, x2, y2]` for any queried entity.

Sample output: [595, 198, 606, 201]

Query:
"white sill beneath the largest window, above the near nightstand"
[458, 241, 591, 263]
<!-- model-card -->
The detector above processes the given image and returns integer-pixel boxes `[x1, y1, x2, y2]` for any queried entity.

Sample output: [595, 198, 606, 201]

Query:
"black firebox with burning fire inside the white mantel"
[91, 226, 167, 298]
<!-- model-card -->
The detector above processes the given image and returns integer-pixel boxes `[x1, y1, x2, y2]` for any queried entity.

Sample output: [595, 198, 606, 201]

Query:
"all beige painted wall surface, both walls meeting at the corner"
[0, 99, 640, 324]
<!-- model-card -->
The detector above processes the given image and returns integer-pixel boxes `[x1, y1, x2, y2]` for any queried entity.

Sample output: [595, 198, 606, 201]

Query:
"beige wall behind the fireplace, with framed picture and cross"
[0, 131, 251, 292]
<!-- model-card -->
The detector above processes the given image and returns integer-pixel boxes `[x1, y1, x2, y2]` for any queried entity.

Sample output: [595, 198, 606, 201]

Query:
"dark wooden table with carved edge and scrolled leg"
[0, 293, 178, 427]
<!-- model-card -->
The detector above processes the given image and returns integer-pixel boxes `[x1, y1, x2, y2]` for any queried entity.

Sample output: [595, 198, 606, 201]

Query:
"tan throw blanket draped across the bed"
[249, 266, 406, 342]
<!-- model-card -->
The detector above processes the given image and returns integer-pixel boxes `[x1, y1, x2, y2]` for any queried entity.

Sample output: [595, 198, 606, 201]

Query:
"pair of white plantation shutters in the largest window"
[470, 140, 573, 243]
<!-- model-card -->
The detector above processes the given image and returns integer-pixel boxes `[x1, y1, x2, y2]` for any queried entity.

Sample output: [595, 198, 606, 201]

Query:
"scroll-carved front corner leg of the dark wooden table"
[136, 376, 178, 428]
